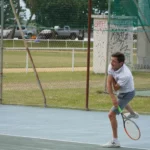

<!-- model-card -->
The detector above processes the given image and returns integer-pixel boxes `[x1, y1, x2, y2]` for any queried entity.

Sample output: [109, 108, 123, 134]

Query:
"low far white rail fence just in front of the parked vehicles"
[4, 39, 137, 50]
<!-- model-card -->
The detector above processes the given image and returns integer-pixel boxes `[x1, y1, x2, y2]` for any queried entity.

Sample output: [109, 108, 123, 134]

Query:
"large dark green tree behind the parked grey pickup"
[24, 0, 108, 28]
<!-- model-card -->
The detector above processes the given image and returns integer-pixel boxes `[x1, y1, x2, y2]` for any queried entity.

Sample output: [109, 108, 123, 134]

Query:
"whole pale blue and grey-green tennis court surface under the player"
[0, 105, 150, 150]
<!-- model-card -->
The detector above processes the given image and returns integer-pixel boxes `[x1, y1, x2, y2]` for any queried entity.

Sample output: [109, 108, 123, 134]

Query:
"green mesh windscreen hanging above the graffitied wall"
[109, 0, 150, 27]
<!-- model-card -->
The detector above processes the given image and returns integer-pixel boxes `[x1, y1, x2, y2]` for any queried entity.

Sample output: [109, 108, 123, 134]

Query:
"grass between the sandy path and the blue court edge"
[3, 72, 150, 113]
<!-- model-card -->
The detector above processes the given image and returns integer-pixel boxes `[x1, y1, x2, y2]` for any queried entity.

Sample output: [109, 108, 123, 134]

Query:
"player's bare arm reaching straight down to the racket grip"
[107, 75, 118, 107]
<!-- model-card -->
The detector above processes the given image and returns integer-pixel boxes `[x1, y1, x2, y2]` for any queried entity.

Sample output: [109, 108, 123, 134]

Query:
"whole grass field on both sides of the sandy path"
[3, 51, 150, 113]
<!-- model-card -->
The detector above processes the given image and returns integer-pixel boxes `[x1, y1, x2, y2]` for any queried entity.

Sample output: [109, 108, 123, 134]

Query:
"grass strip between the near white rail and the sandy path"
[3, 50, 93, 68]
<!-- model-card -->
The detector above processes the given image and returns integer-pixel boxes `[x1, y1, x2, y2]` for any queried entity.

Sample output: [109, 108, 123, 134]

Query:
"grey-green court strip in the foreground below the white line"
[0, 135, 145, 150]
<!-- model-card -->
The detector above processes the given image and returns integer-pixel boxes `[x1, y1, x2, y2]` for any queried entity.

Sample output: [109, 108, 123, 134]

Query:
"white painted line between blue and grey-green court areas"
[0, 133, 150, 150]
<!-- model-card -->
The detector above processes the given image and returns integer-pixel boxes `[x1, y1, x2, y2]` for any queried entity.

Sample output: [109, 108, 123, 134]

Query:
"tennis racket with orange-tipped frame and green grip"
[118, 106, 141, 140]
